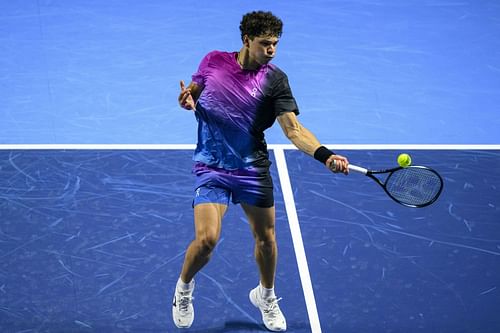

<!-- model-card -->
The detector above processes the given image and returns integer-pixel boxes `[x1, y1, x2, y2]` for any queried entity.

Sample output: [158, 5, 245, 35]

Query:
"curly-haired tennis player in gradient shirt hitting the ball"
[172, 11, 348, 331]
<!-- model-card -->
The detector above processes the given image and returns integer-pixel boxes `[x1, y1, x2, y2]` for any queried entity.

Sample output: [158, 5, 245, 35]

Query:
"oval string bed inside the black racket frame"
[385, 168, 442, 206]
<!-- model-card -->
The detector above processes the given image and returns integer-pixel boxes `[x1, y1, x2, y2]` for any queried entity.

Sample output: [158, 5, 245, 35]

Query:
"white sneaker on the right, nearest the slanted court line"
[248, 286, 286, 332]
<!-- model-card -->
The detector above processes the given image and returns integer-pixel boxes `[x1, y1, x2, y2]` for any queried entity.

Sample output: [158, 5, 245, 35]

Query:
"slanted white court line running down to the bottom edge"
[274, 148, 321, 333]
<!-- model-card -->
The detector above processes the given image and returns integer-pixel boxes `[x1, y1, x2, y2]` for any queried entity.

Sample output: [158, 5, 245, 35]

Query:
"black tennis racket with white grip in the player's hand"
[349, 164, 444, 208]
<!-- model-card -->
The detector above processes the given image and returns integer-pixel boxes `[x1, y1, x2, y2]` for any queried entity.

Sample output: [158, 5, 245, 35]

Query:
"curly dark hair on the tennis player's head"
[240, 11, 283, 40]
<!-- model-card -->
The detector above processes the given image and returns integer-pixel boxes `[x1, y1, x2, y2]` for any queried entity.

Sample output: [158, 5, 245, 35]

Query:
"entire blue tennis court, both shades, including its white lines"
[0, 0, 500, 333]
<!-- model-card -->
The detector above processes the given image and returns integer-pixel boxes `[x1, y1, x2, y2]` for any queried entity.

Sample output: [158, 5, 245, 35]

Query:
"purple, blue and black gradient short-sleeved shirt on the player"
[192, 51, 299, 170]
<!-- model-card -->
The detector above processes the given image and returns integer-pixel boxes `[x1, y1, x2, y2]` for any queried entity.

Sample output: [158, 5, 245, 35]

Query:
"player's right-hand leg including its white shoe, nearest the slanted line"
[241, 203, 286, 331]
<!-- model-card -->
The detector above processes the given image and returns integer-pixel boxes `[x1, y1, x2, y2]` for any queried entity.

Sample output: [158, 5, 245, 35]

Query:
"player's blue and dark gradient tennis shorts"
[193, 163, 274, 208]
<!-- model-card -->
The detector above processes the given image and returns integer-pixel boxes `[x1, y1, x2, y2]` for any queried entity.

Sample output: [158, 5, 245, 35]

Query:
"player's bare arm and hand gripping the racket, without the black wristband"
[277, 112, 349, 174]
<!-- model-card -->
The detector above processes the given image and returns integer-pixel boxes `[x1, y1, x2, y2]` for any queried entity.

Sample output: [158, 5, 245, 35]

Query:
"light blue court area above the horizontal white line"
[0, 0, 500, 144]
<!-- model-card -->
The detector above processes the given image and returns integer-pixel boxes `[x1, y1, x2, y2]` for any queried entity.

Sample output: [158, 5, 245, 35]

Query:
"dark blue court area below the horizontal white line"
[0, 149, 500, 332]
